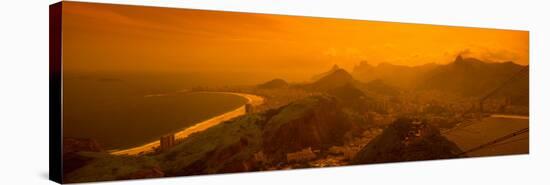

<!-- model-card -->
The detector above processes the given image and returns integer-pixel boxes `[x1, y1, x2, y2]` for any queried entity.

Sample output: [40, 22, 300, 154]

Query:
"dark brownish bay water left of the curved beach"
[63, 73, 247, 150]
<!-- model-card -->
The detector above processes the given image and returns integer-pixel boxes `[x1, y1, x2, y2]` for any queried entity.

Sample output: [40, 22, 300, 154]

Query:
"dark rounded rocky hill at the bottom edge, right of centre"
[352, 118, 462, 164]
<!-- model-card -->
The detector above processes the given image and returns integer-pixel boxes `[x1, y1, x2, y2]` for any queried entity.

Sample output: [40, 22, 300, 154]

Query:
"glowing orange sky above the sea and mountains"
[63, 2, 529, 79]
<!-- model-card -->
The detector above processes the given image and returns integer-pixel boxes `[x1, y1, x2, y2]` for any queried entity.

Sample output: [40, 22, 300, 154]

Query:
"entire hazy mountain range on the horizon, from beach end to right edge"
[264, 56, 529, 104]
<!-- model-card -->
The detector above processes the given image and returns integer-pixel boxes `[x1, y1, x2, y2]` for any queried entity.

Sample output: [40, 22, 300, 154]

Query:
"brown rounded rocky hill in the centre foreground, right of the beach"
[262, 96, 356, 159]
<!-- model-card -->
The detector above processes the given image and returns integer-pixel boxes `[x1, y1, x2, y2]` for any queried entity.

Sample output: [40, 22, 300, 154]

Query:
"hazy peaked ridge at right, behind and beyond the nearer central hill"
[352, 56, 529, 100]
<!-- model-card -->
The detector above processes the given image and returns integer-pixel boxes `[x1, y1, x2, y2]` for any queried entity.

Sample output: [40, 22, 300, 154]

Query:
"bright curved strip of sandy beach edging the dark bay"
[110, 92, 264, 155]
